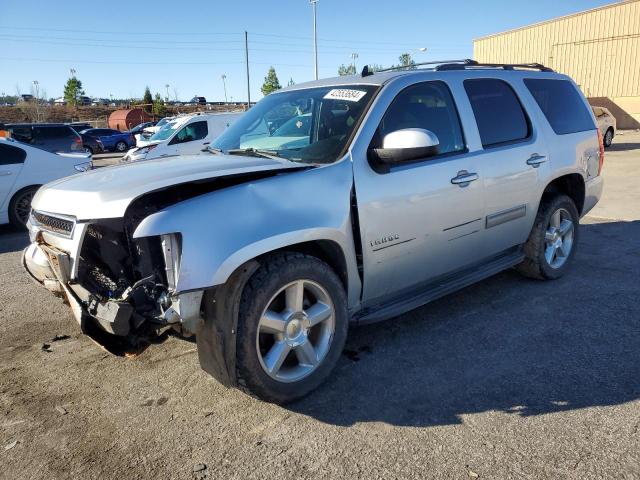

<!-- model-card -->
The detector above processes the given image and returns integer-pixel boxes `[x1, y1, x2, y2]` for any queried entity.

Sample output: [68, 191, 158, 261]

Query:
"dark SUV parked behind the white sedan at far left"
[6, 123, 82, 153]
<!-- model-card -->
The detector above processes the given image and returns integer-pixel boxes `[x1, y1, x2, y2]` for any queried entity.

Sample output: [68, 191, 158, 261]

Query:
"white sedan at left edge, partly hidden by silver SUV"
[0, 137, 89, 226]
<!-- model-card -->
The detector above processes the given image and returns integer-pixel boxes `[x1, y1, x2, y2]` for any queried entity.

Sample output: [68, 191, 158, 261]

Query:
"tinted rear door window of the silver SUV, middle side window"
[464, 78, 530, 147]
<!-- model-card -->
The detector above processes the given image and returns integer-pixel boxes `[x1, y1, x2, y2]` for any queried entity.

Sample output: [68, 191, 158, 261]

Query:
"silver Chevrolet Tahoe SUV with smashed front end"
[24, 61, 603, 403]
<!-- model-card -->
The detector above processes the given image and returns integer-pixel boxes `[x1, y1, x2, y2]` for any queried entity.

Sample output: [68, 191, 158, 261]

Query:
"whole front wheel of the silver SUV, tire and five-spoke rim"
[236, 253, 348, 403]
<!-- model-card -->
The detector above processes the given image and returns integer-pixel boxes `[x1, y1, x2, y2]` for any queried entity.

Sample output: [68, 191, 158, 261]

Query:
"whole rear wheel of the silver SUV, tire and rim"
[516, 195, 579, 280]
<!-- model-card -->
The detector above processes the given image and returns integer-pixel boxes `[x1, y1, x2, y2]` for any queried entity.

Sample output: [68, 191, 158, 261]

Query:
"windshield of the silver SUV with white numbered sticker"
[211, 85, 376, 163]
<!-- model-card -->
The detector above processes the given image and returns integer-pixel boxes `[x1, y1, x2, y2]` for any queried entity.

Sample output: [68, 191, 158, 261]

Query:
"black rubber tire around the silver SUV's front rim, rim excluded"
[236, 253, 349, 404]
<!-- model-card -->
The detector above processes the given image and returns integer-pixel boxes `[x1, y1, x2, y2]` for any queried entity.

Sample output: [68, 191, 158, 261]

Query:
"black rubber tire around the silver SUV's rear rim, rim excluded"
[516, 194, 580, 280]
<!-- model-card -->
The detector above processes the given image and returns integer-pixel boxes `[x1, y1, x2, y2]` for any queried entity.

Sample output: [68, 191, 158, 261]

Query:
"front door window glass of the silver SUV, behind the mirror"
[376, 82, 465, 154]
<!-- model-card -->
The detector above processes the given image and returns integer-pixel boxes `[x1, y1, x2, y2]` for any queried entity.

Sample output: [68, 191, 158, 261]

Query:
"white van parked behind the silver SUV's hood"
[122, 112, 242, 162]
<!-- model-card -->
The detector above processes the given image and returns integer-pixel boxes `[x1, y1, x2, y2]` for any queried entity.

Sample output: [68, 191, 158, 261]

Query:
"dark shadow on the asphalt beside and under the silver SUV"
[288, 222, 640, 427]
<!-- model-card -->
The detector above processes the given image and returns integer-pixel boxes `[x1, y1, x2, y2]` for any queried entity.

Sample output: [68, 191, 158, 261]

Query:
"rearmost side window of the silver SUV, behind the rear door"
[524, 78, 603, 135]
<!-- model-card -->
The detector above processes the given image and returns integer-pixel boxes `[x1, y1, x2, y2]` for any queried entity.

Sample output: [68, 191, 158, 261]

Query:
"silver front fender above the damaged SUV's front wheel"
[133, 159, 361, 306]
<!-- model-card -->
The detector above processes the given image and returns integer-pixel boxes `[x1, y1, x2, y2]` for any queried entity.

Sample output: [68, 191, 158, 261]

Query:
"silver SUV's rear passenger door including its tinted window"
[464, 78, 549, 257]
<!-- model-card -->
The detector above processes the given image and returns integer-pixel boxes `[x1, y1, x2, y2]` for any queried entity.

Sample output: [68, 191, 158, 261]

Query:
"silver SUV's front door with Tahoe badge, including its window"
[354, 81, 484, 306]
